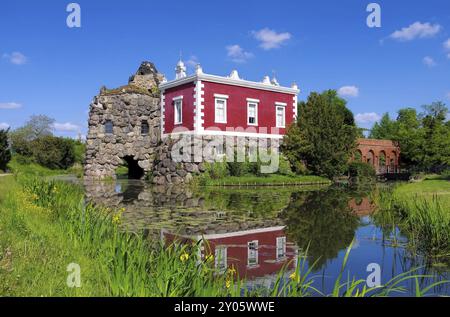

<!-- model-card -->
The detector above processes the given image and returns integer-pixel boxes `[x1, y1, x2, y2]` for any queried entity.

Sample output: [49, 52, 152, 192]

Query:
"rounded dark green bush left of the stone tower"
[31, 135, 75, 169]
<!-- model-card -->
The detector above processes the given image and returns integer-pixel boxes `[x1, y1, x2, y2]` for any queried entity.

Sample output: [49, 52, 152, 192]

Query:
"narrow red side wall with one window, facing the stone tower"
[164, 83, 195, 133]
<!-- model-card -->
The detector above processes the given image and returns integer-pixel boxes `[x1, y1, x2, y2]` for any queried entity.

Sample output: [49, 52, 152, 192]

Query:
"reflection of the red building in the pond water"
[162, 226, 298, 279]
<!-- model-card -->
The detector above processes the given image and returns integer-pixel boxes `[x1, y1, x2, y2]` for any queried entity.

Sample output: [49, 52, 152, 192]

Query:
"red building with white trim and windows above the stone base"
[159, 61, 299, 138]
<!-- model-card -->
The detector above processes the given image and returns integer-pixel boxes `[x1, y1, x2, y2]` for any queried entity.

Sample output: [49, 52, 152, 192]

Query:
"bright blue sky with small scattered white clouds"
[0, 0, 450, 137]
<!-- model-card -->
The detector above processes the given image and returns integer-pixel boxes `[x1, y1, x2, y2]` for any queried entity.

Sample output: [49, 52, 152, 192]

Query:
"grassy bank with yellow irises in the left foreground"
[0, 170, 446, 296]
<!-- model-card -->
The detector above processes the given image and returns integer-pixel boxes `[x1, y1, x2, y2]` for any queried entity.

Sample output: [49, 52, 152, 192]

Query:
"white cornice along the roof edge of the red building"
[159, 73, 300, 95]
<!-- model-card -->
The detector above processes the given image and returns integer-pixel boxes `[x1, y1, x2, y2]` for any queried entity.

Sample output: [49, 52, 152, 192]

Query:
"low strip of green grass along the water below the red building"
[200, 174, 331, 186]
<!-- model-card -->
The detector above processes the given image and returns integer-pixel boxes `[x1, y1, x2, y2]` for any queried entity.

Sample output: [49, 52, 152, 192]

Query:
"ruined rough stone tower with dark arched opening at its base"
[84, 62, 162, 180]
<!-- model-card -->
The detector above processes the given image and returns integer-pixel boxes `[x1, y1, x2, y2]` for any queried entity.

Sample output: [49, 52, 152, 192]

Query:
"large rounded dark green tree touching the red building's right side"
[281, 90, 358, 178]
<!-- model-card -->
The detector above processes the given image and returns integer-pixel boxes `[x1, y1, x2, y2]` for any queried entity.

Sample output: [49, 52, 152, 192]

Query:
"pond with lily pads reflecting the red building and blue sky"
[85, 180, 450, 296]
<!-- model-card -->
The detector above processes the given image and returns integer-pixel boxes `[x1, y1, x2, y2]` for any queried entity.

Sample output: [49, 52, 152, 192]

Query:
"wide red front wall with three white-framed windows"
[203, 82, 294, 134]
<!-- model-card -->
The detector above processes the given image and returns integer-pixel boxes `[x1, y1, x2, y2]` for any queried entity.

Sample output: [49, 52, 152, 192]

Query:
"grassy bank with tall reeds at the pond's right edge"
[380, 180, 450, 262]
